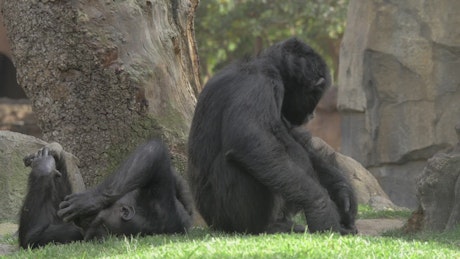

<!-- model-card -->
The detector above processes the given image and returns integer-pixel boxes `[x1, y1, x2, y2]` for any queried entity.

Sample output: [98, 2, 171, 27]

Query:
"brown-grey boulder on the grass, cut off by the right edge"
[417, 123, 460, 231]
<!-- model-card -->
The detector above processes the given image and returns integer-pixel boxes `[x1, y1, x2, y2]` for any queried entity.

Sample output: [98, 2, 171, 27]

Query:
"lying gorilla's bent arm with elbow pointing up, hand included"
[58, 140, 174, 222]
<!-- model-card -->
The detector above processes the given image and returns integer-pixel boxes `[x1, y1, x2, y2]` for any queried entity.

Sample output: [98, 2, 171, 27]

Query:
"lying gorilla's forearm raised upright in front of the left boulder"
[18, 148, 83, 248]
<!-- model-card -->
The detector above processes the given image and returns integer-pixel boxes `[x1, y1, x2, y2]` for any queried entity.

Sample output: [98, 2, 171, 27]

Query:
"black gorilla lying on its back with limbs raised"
[19, 140, 193, 248]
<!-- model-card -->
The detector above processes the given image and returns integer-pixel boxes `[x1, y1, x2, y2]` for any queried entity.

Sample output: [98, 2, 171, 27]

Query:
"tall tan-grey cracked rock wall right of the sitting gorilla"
[338, 0, 460, 208]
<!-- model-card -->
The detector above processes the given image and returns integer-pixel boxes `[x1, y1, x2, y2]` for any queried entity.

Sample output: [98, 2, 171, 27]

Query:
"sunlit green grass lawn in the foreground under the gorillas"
[0, 207, 460, 258]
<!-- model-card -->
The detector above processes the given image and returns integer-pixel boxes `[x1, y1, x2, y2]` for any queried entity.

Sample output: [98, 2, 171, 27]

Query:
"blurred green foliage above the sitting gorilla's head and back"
[195, 0, 348, 82]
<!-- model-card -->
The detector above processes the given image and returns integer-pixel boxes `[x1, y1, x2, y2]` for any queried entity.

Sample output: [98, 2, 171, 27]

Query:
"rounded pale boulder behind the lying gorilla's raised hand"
[0, 130, 85, 222]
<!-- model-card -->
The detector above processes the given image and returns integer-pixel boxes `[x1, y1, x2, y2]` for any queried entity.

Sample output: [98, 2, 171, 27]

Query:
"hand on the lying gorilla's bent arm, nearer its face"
[58, 191, 104, 222]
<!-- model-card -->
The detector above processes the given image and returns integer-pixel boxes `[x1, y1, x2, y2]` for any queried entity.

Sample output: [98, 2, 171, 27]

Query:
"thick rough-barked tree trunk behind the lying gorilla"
[0, 0, 200, 186]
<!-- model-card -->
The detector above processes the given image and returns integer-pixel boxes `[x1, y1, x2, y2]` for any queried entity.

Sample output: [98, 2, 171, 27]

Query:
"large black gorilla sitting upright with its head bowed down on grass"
[188, 38, 357, 234]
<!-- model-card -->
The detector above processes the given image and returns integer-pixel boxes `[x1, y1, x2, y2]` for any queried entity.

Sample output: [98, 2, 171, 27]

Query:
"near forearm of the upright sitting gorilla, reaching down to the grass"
[226, 120, 341, 232]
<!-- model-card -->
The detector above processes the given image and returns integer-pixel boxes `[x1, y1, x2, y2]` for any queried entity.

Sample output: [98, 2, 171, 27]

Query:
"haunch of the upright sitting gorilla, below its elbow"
[195, 155, 276, 234]
